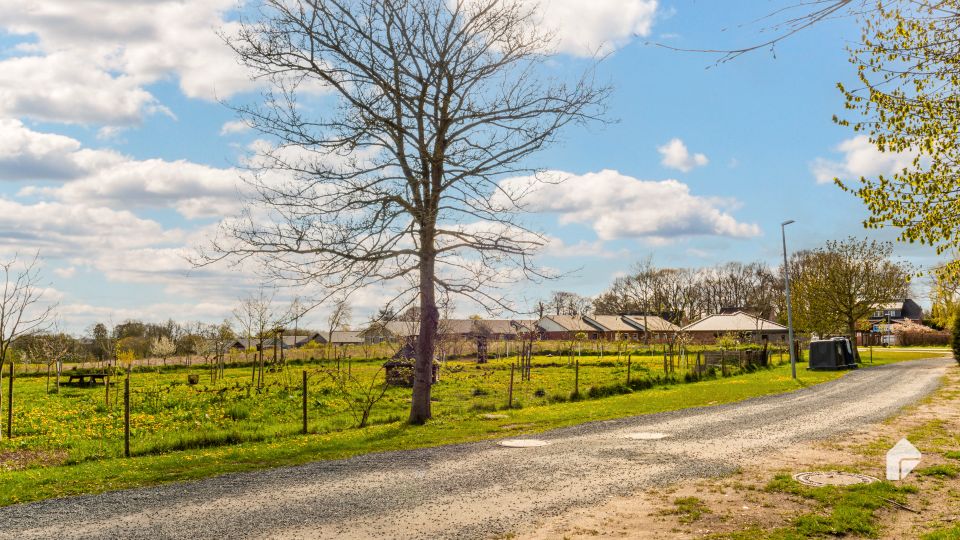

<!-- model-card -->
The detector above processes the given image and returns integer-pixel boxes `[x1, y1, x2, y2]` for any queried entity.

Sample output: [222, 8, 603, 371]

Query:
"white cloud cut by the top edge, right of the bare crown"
[528, 0, 658, 56]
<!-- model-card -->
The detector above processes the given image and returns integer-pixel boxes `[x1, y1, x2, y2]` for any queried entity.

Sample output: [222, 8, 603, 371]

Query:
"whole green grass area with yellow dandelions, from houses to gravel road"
[0, 350, 944, 505]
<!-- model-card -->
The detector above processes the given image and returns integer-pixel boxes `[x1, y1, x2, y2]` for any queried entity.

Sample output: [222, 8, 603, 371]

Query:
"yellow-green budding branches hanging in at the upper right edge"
[836, 0, 960, 273]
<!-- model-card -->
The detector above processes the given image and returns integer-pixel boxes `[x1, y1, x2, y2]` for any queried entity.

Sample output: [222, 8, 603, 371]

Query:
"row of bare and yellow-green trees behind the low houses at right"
[538, 238, 916, 348]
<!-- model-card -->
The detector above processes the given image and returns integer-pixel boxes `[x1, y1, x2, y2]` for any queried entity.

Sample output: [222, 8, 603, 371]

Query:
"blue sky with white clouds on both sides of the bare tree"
[0, 0, 937, 331]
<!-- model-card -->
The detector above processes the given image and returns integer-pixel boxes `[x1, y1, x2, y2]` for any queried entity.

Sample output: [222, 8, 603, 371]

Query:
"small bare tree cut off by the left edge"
[0, 253, 54, 436]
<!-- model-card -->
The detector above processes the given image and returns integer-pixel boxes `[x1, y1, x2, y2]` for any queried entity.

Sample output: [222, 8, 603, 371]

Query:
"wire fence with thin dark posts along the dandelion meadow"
[0, 347, 788, 465]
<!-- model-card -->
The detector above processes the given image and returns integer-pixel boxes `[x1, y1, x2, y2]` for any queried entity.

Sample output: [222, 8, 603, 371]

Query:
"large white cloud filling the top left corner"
[0, 0, 254, 124]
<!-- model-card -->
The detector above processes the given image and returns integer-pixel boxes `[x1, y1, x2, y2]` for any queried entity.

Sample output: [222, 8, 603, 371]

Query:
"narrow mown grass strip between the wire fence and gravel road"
[0, 355, 944, 505]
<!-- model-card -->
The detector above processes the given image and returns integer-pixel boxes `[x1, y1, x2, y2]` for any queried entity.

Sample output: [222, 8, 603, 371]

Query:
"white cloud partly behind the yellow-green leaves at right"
[810, 135, 915, 184]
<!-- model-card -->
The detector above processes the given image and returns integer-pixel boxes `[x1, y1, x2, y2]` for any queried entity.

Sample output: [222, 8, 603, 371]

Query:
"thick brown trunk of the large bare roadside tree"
[410, 255, 440, 424]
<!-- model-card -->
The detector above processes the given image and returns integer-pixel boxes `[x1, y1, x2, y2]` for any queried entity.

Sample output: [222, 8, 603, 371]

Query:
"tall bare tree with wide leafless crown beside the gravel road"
[206, 0, 609, 423]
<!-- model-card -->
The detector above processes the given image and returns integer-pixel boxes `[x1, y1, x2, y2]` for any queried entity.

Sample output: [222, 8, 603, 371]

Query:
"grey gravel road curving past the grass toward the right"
[0, 359, 951, 540]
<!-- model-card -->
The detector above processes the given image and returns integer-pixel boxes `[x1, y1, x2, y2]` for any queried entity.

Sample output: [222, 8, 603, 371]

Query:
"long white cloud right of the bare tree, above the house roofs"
[495, 170, 760, 242]
